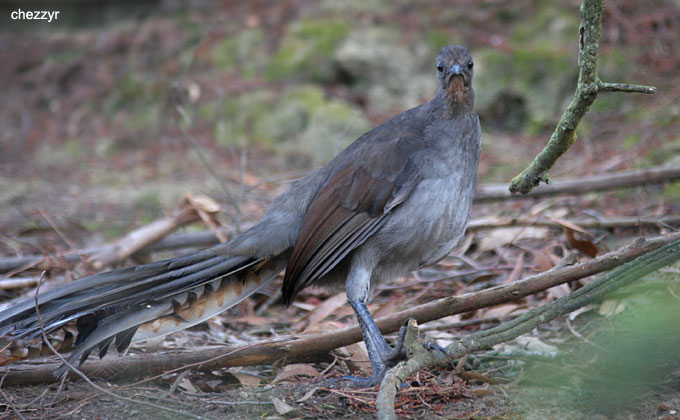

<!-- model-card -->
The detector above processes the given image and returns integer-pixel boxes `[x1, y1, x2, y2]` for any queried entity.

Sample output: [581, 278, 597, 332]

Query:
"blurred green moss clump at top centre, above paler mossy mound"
[266, 19, 350, 80]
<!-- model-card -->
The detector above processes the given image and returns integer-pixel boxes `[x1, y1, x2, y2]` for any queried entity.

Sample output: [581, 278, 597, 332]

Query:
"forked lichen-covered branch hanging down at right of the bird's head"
[509, 0, 656, 194]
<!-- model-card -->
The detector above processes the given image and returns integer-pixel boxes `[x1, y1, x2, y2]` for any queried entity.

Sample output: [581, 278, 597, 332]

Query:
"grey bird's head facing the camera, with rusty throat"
[436, 45, 474, 105]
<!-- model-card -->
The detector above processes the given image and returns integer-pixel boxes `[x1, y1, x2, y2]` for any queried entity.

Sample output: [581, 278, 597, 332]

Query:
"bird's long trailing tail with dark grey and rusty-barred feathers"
[0, 246, 287, 375]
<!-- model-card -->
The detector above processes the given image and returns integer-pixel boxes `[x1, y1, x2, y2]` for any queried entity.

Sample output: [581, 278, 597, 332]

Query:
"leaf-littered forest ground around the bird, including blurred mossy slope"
[0, 0, 680, 419]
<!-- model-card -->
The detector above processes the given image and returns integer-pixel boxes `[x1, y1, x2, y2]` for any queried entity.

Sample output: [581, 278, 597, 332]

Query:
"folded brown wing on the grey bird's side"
[283, 139, 420, 303]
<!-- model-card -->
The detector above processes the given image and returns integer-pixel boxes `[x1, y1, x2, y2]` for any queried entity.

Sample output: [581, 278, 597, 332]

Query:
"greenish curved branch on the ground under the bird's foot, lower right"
[376, 240, 680, 420]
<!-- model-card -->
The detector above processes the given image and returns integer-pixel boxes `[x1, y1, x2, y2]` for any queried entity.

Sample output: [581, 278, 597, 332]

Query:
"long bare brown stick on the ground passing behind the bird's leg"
[0, 233, 680, 385]
